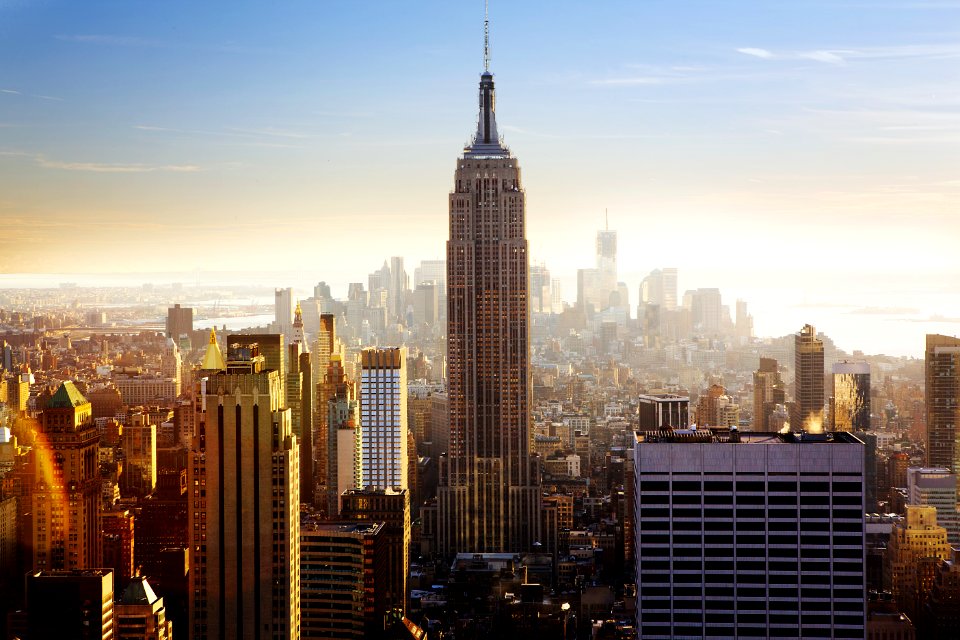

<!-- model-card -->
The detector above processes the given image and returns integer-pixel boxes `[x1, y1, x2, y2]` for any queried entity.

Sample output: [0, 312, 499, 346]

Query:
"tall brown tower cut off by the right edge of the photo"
[926, 334, 960, 473]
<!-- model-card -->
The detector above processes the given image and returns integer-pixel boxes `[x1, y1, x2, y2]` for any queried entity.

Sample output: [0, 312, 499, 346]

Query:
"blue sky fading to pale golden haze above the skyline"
[0, 0, 960, 352]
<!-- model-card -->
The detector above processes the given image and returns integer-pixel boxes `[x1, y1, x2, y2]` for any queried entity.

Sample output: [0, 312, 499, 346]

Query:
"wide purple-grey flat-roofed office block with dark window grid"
[634, 429, 866, 638]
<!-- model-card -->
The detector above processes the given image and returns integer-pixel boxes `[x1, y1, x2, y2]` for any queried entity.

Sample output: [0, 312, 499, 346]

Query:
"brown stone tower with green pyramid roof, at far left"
[32, 382, 100, 580]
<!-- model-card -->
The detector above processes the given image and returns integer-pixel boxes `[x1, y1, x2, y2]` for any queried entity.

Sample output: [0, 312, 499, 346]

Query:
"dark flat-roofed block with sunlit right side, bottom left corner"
[25, 569, 117, 640]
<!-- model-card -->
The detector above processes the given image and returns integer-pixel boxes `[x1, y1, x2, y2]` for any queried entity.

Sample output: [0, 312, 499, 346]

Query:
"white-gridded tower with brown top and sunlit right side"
[359, 348, 407, 489]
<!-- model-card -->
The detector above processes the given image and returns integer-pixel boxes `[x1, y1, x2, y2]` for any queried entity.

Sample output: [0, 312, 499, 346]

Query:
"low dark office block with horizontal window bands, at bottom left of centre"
[300, 514, 389, 640]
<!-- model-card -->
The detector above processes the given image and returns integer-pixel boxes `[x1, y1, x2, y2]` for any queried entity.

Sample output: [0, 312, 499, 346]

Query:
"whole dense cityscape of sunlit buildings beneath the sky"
[0, 1, 960, 640]
